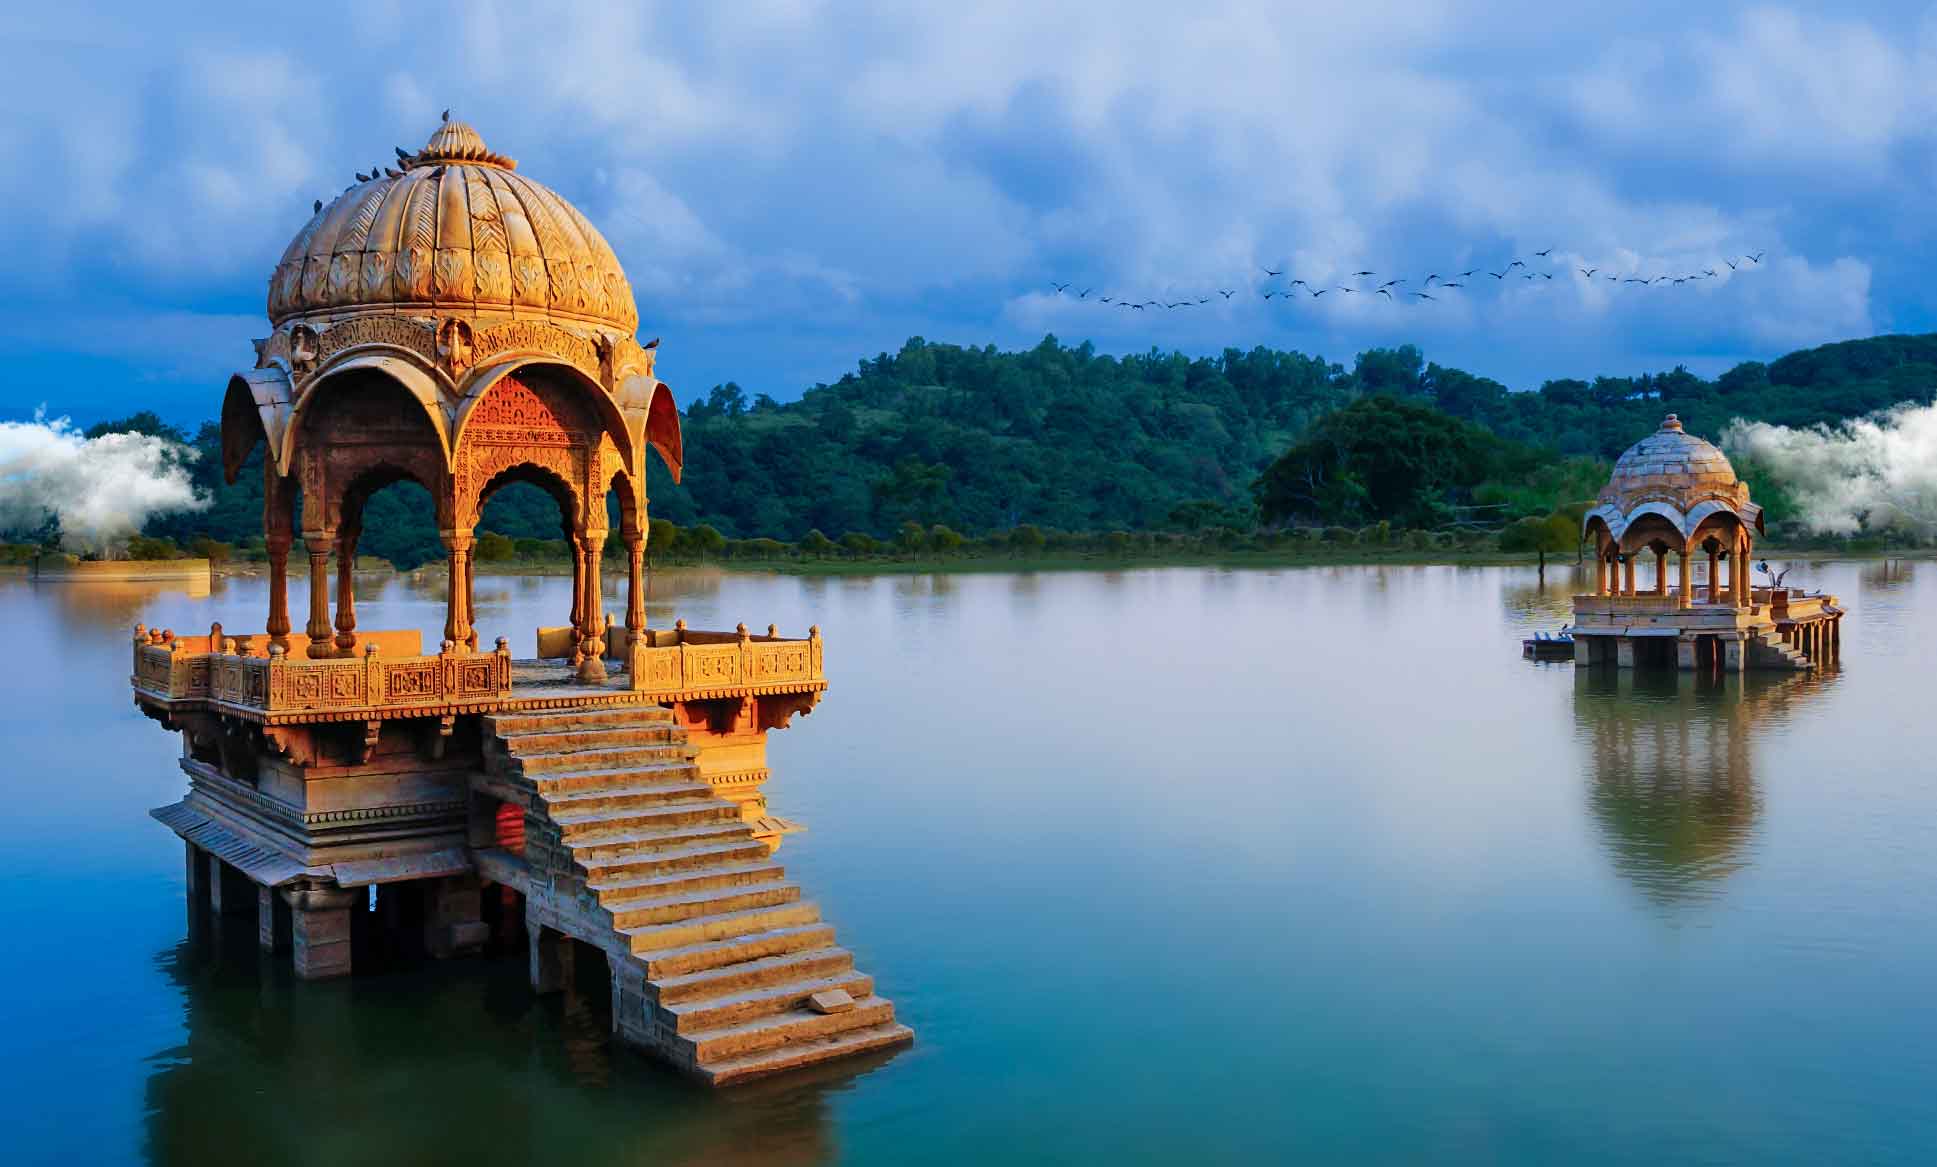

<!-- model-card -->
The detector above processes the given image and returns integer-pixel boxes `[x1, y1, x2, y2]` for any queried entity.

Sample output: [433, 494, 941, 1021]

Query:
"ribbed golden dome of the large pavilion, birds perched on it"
[269, 122, 639, 335]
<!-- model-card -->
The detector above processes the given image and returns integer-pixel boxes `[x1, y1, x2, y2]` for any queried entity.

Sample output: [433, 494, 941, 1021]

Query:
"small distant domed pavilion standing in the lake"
[1573, 413, 1842, 671]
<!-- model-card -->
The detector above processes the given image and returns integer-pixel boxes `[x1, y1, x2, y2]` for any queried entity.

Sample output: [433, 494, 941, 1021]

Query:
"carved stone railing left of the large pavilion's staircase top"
[134, 630, 511, 715]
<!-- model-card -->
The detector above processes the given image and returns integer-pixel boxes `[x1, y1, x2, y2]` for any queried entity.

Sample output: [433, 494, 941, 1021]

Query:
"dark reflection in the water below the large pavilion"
[145, 927, 866, 1167]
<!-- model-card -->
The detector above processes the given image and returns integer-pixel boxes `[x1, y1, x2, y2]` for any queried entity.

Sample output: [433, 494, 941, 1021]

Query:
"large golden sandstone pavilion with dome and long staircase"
[134, 120, 912, 1084]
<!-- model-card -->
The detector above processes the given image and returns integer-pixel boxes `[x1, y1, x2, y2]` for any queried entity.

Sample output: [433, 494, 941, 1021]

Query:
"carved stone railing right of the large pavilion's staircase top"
[628, 620, 827, 700]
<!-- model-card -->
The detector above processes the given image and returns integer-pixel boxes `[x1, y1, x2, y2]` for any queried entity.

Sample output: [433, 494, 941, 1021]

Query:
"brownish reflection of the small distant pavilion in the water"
[1573, 669, 1830, 907]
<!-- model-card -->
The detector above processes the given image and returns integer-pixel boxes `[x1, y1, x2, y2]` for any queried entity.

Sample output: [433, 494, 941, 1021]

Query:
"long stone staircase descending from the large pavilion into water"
[484, 693, 914, 1086]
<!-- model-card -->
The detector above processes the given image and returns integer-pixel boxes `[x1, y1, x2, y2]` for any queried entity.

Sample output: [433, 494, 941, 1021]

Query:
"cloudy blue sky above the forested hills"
[0, 0, 1937, 423]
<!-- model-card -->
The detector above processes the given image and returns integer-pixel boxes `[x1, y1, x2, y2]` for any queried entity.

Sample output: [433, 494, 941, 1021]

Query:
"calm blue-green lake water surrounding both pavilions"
[0, 564, 1937, 1167]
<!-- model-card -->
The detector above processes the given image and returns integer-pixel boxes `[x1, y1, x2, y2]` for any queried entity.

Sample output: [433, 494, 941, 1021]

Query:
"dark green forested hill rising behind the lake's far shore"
[651, 333, 1937, 539]
